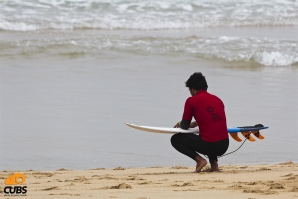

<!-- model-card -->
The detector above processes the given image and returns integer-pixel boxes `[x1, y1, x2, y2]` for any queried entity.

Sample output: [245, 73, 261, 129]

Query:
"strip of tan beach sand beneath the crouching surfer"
[0, 162, 298, 199]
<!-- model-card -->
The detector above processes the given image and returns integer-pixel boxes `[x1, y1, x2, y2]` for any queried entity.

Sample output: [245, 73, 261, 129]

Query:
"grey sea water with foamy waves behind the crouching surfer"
[0, 0, 298, 170]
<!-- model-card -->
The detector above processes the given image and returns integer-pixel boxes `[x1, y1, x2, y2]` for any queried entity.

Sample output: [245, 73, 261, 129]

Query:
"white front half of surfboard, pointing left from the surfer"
[125, 123, 200, 134]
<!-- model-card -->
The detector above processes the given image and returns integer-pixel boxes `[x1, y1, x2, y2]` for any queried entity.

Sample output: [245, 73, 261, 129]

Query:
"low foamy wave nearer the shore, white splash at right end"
[0, 35, 298, 67]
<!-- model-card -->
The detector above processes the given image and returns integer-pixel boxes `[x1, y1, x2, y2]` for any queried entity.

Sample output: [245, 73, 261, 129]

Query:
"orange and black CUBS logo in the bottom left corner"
[4, 173, 27, 196]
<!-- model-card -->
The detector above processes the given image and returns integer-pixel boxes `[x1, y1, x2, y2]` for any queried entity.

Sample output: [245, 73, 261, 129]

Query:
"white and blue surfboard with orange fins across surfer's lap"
[125, 122, 269, 142]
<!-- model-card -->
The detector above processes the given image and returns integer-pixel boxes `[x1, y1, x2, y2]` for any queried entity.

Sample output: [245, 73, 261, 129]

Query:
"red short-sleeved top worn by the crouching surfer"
[182, 90, 229, 142]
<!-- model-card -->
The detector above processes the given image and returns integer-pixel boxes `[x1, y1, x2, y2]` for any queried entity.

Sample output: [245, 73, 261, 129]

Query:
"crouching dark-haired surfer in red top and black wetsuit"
[171, 72, 229, 172]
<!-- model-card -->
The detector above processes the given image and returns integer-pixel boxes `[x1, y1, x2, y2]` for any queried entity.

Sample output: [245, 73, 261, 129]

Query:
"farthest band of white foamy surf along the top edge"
[0, 0, 298, 31]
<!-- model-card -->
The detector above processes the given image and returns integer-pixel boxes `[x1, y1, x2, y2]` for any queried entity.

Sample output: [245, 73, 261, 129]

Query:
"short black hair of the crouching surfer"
[185, 72, 208, 90]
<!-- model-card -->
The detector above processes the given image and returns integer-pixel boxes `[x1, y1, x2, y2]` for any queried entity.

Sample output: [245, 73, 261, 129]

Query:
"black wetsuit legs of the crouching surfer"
[171, 133, 229, 163]
